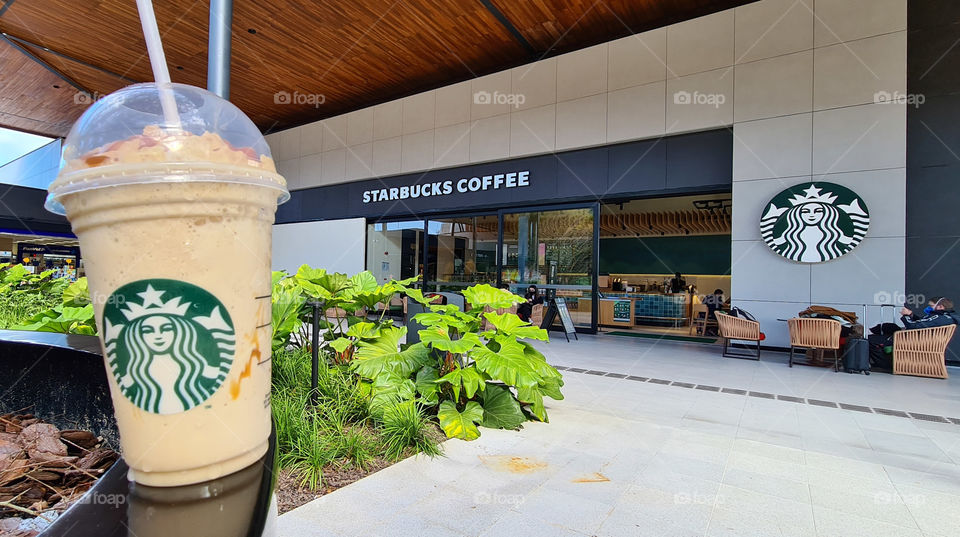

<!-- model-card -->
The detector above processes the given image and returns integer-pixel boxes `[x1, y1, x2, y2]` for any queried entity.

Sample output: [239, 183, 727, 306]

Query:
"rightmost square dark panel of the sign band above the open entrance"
[666, 129, 733, 190]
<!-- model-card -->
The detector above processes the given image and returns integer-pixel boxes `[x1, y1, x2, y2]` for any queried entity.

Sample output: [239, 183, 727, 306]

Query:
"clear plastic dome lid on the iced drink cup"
[46, 82, 290, 214]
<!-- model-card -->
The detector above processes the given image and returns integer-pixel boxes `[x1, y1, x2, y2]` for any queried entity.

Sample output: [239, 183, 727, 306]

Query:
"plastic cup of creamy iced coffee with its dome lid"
[46, 84, 289, 487]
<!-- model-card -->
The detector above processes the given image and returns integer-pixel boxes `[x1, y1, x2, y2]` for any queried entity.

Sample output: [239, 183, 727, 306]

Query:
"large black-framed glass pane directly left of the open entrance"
[501, 208, 594, 328]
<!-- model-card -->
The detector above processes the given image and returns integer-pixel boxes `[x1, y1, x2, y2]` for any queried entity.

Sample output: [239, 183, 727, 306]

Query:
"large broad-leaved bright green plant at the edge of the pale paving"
[348, 282, 563, 440]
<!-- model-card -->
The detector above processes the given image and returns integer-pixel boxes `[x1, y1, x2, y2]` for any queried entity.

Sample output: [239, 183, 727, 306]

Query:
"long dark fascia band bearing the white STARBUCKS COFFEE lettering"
[277, 129, 733, 223]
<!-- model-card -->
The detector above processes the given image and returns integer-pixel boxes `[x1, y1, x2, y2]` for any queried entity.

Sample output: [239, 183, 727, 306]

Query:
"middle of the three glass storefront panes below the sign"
[425, 214, 498, 291]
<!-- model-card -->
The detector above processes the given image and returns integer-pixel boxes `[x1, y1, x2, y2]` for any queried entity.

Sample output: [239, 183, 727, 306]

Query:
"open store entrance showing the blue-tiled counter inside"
[597, 193, 731, 340]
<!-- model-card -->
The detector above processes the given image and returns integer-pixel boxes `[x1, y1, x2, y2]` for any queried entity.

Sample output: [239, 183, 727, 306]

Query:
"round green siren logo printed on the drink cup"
[102, 279, 235, 414]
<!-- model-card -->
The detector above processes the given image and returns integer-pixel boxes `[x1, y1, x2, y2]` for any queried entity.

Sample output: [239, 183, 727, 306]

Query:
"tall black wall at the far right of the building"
[906, 0, 960, 363]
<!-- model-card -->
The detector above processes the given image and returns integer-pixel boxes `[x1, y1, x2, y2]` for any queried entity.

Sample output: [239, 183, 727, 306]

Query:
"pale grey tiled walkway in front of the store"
[279, 336, 960, 537]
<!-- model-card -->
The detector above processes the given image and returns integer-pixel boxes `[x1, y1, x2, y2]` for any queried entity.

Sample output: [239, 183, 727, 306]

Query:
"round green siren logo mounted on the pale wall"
[760, 181, 870, 263]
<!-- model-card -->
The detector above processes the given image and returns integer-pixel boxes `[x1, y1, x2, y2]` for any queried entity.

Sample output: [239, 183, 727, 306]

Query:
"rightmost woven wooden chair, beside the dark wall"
[893, 324, 957, 379]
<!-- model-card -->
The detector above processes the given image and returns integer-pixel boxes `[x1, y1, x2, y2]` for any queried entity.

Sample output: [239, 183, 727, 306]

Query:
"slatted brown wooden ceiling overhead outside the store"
[0, 0, 753, 136]
